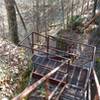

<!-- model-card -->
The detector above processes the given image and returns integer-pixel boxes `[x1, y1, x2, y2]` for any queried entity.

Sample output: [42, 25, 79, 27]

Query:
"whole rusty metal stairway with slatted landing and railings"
[13, 33, 95, 100]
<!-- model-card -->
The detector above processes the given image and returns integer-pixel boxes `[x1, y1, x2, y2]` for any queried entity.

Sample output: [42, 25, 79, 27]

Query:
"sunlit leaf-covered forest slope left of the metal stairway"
[0, 38, 30, 100]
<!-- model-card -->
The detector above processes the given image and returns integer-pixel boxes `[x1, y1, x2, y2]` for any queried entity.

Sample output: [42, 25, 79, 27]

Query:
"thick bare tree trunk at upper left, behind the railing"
[4, 0, 19, 44]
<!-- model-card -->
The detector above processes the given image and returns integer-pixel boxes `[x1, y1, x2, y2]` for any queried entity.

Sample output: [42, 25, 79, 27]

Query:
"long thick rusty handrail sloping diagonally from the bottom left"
[12, 62, 66, 100]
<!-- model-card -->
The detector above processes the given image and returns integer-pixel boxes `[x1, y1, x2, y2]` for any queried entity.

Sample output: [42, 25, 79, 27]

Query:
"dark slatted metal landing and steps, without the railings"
[28, 55, 89, 100]
